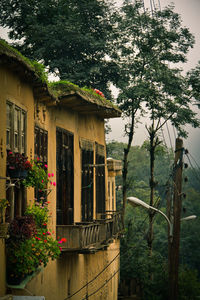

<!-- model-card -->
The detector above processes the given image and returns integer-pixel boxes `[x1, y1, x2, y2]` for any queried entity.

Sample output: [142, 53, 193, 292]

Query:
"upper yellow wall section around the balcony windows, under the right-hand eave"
[35, 104, 107, 226]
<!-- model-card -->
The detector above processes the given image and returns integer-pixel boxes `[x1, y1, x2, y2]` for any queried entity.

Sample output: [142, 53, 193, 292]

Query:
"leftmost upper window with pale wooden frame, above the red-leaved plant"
[6, 101, 26, 154]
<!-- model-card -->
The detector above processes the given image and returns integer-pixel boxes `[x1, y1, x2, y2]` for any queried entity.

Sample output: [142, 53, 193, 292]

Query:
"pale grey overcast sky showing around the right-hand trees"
[108, 0, 200, 162]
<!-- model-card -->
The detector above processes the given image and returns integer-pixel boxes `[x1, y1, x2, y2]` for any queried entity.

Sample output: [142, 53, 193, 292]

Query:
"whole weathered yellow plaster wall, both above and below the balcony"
[0, 65, 119, 300]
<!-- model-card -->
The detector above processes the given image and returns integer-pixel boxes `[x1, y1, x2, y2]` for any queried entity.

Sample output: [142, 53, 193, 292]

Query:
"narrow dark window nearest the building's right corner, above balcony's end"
[95, 144, 105, 217]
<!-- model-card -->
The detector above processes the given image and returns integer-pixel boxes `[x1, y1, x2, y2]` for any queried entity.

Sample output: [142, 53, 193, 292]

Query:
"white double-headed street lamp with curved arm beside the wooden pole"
[127, 197, 197, 241]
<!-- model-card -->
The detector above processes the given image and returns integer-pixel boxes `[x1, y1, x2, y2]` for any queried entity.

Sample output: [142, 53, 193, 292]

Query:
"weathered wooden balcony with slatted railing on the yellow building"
[56, 212, 124, 253]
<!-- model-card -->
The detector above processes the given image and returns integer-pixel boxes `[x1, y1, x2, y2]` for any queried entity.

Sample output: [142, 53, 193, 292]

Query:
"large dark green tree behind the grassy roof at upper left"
[0, 0, 118, 93]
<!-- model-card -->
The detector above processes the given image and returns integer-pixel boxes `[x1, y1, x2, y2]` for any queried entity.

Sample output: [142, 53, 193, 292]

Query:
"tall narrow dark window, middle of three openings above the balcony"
[80, 139, 94, 222]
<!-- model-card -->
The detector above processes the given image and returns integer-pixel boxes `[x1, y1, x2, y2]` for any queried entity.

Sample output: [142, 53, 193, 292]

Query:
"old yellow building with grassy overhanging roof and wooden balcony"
[0, 42, 122, 300]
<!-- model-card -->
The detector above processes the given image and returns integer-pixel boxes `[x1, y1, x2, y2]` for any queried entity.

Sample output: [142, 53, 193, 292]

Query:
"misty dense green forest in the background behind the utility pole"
[107, 141, 200, 300]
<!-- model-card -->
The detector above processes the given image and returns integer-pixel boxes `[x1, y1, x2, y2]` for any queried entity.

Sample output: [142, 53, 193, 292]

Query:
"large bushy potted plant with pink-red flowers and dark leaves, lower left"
[6, 202, 66, 285]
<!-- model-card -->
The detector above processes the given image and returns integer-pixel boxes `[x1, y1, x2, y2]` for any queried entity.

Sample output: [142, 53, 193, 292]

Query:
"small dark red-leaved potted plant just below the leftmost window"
[7, 151, 32, 178]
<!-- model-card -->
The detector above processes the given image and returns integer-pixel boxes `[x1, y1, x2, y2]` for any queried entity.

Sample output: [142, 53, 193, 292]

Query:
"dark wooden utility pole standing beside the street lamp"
[169, 138, 184, 300]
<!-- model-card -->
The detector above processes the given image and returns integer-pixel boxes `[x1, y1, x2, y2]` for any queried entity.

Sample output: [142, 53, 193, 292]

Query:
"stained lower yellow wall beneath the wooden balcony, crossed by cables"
[13, 241, 119, 300]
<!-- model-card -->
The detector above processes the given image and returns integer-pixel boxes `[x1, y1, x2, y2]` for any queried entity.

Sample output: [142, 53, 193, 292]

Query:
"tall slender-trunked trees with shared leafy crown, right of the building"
[112, 0, 199, 252]
